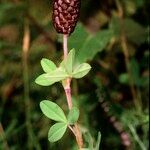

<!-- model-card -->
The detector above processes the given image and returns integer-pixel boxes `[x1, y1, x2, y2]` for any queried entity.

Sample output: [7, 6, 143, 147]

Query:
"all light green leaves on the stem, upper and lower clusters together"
[35, 49, 91, 142]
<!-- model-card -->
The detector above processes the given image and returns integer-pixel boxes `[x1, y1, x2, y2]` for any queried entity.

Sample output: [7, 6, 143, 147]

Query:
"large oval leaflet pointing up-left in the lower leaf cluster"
[40, 100, 67, 122]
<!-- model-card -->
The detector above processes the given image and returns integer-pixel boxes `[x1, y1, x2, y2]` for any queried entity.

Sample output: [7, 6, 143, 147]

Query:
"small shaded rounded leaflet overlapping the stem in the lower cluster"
[67, 107, 79, 125]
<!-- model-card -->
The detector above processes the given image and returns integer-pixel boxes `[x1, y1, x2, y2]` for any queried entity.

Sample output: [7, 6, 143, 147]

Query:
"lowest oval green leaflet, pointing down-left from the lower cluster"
[48, 123, 67, 142]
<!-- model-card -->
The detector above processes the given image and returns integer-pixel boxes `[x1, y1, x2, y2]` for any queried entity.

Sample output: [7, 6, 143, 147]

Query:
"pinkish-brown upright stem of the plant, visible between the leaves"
[63, 34, 83, 149]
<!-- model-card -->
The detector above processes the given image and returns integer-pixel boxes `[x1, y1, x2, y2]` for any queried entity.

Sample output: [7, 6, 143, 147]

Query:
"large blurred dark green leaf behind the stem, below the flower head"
[69, 24, 113, 63]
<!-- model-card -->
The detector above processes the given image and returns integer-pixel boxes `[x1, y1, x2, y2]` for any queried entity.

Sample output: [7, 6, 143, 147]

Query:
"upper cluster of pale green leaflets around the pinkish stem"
[35, 49, 91, 86]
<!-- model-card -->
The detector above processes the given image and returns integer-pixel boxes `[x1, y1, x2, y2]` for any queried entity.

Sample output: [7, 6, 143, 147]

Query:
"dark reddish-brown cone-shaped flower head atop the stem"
[52, 0, 81, 34]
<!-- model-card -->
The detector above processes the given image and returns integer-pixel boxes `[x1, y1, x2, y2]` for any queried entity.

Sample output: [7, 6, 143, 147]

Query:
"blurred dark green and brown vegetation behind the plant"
[0, 0, 150, 150]
